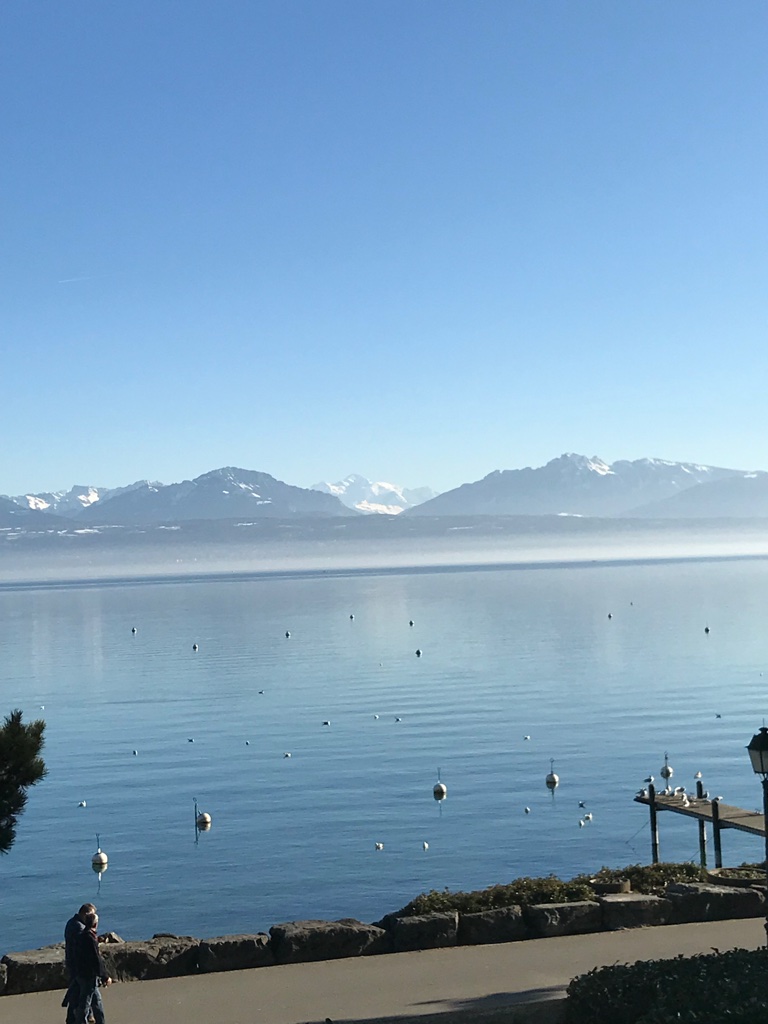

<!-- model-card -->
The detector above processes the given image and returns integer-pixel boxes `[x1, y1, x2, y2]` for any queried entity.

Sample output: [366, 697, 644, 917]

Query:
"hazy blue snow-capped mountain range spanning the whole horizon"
[0, 454, 768, 530]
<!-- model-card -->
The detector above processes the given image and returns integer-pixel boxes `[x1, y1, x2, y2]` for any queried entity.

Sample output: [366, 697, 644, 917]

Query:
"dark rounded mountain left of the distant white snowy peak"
[78, 466, 354, 524]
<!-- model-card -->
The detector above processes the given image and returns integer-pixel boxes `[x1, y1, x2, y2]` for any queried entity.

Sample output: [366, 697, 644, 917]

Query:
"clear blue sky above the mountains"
[0, 0, 768, 494]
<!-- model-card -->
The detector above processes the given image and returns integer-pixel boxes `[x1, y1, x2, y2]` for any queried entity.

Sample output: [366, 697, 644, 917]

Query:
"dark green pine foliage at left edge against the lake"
[0, 711, 47, 853]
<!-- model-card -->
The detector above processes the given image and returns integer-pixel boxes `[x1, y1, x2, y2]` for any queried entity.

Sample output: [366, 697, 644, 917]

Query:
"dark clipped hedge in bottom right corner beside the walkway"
[565, 948, 768, 1024]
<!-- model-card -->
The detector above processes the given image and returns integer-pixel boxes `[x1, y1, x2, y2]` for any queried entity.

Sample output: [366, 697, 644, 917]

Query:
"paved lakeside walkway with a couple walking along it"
[6, 919, 765, 1024]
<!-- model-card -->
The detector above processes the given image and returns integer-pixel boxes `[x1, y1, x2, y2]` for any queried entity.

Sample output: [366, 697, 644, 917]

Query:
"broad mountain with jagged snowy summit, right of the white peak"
[408, 453, 743, 516]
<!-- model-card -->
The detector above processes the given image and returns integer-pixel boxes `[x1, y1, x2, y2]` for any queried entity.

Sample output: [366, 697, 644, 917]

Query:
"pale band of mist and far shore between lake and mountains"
[0, 516, 768, 582]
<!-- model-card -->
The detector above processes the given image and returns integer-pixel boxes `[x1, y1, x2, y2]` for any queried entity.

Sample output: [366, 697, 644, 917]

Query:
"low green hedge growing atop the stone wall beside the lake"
[396, 863, 707, 918]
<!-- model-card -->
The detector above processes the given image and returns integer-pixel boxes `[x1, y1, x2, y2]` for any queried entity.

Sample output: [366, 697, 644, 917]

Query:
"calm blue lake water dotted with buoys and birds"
[0, 559, 768, 953]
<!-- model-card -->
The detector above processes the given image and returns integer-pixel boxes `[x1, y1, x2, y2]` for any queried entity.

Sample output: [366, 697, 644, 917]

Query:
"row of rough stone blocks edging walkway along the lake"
[0, 883, 766, 995]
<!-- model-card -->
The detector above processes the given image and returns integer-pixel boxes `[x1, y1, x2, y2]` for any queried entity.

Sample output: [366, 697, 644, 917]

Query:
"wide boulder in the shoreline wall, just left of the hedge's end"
[269, 918, 389, 964]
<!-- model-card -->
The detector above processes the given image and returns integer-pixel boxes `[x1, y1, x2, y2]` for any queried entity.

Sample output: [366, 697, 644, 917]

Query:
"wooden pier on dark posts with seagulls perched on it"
[635, 782, 766, 867]
